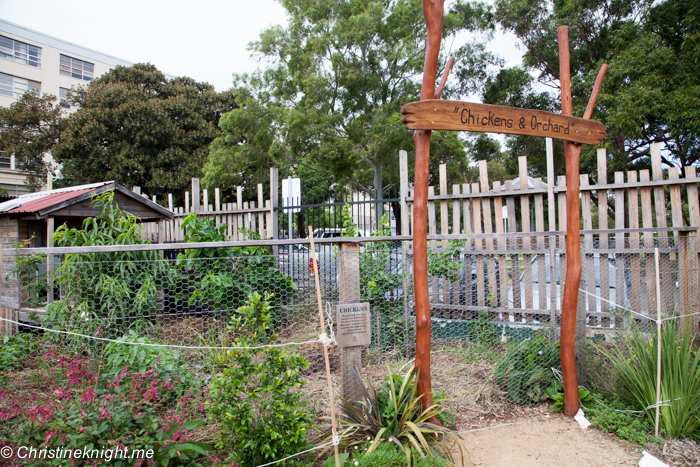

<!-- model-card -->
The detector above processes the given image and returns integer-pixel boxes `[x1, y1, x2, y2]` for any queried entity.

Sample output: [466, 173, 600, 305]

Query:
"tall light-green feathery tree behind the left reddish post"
[205, 0, 496, 205]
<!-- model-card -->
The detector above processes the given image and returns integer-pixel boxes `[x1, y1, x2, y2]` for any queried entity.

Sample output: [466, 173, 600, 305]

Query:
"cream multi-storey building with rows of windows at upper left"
[0, 18, 133, 196]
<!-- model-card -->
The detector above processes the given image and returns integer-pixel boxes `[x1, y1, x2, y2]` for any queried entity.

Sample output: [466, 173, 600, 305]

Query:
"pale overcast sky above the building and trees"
[0, 0, 520, 91]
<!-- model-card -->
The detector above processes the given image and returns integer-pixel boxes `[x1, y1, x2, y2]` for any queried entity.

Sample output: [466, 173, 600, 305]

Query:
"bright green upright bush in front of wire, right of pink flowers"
[207, 293, 313, 465]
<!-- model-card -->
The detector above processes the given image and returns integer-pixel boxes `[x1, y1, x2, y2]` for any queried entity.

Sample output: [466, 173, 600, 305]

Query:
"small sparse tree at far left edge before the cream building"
[0, 91, 65, 191]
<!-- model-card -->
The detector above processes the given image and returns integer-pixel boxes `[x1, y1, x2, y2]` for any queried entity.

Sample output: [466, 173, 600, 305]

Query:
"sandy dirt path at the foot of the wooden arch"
[462, 414, 642, 467]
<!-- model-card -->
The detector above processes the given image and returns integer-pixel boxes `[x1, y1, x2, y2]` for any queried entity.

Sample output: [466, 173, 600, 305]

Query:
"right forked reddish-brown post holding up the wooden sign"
[557, 26, 608, 417]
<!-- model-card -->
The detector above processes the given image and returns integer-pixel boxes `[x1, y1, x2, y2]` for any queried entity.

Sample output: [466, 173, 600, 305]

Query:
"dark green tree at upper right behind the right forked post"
[468, 0, 700, 179]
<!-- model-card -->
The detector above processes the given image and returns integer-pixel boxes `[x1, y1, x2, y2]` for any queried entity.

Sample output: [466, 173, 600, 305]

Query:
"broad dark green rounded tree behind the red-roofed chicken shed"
[53, 64, 235, 196]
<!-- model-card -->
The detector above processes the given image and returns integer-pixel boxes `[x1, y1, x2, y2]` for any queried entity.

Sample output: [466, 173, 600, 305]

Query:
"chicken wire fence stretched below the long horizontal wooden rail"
[0, 234, 698, 454]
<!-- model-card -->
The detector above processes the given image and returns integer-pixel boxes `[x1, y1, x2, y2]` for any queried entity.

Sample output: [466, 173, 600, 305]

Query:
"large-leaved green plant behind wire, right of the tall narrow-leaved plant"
[177, 212, 297, 313]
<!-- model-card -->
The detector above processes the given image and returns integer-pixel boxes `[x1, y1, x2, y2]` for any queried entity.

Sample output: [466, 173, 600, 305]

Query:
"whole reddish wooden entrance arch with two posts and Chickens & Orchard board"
[408, 0, 608, 417]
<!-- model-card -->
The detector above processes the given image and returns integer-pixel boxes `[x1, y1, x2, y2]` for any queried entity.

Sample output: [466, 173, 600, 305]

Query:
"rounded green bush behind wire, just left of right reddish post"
[494, 337, 561, 405]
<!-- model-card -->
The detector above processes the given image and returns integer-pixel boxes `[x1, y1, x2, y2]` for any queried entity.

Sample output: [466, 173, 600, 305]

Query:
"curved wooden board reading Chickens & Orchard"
[401, 99, 605, 144]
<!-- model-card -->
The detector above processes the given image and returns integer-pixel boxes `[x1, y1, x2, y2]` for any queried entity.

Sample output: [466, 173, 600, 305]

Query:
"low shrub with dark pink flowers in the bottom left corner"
[0, 351, 210, 466]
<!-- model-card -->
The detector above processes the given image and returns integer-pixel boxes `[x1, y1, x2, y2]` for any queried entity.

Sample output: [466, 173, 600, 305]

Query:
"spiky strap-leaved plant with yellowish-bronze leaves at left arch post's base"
[339, 366, 464, 466]
